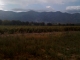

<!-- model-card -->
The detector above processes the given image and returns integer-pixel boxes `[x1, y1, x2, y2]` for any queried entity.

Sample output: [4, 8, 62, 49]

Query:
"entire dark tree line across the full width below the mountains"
[0, 20, 80, 26]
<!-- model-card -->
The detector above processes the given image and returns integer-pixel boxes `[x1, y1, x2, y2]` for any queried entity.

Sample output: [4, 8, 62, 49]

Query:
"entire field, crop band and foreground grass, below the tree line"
[0, 26, 80, 60]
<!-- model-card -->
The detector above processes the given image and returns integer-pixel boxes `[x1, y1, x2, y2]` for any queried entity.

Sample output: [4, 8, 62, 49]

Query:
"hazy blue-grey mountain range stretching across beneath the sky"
[0, 11, 80, 23]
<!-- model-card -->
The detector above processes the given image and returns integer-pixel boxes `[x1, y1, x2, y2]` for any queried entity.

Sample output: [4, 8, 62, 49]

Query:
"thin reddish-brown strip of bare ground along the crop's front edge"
[0, 32, 65, 36]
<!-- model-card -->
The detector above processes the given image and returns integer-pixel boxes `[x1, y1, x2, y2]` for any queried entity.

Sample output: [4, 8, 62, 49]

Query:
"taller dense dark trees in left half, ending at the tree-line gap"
[0, 20, 45, 26]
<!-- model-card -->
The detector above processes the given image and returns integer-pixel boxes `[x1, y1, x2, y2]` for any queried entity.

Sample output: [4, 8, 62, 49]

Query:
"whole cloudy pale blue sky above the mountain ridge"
[0, 0, 80, 13]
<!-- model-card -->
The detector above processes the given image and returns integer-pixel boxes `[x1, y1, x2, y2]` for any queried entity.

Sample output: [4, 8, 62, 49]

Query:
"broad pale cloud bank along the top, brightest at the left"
[0, 0, 77, 9]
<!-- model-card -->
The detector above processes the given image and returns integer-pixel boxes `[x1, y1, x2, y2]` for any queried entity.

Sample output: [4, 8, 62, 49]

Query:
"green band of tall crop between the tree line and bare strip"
[0, 26, 80, 34]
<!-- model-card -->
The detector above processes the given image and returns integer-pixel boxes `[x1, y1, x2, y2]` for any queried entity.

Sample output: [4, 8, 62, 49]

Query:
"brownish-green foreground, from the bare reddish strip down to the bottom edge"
[0, 32, 80, 60]
